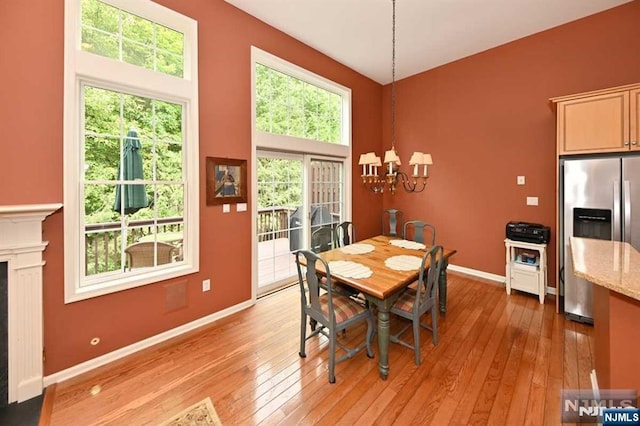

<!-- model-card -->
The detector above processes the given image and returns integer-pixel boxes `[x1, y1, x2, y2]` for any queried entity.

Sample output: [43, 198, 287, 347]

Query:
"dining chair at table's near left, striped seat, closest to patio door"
[295, 250, 375, 383]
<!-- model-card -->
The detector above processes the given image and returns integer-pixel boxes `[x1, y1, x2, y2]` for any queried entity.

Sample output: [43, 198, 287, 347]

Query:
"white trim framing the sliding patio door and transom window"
[251, 46, 353, 302]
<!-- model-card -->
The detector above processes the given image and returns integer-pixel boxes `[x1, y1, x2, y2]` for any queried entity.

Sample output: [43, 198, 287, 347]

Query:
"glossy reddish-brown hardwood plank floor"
[41, 274, 593, 426]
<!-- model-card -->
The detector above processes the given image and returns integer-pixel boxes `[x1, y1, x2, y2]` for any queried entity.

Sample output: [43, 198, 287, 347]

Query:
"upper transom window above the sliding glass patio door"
[252, 47, 351, 157]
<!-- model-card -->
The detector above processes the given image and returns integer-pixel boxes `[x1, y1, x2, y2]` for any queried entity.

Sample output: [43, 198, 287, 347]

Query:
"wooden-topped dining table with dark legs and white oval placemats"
[308, 235, 456, 380]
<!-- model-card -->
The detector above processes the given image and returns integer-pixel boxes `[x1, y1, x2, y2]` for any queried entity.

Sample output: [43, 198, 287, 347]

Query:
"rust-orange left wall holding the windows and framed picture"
[0, 0, 382, 375]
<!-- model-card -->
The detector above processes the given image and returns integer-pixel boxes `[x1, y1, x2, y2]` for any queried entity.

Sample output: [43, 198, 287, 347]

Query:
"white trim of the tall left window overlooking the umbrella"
[64, 0, 200, 303]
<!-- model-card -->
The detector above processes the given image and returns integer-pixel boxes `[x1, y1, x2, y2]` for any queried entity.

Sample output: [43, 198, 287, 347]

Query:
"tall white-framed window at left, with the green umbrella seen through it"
[64, 0, 199, 302]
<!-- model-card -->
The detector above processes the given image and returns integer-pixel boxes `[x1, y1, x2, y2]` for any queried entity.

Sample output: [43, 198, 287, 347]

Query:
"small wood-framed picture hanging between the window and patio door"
[206, 157, 247, 206]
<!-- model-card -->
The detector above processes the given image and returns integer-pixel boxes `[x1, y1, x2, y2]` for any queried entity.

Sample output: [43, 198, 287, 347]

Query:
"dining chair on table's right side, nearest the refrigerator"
[389, 246, 444, 365]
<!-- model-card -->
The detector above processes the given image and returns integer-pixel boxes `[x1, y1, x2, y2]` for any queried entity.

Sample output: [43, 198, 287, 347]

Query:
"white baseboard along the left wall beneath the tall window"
[44, 300, 255, 387]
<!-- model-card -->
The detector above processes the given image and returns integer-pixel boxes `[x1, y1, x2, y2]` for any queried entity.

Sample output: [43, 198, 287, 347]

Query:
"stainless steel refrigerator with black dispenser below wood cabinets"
[559, 156, 640, 323]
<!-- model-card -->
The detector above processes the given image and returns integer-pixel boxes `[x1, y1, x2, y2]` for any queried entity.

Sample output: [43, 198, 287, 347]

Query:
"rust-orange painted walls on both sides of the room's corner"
[5, 0, 640, 375]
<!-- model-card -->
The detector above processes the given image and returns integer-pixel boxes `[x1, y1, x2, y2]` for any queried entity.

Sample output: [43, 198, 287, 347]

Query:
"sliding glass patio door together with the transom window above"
[252, 48, 351, 295]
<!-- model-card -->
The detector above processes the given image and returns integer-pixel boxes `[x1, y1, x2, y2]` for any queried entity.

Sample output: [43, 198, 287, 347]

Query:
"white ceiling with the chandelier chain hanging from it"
[225, 0, 633, 84]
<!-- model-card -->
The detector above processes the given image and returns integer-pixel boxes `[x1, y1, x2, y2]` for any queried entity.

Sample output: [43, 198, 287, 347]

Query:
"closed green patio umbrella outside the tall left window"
[113, 129, 149, 214]
